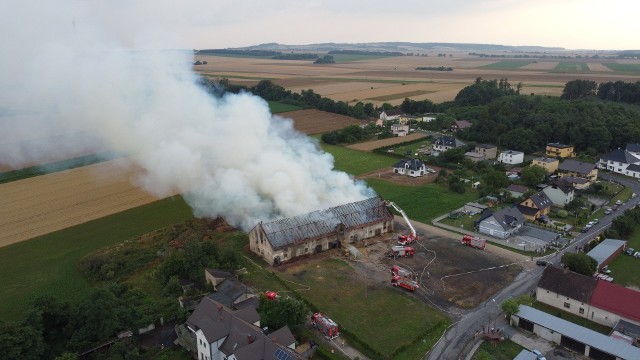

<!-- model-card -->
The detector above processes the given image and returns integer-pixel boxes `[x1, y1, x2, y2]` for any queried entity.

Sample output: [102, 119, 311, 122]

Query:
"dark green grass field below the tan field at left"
[0, 197, 193, 320]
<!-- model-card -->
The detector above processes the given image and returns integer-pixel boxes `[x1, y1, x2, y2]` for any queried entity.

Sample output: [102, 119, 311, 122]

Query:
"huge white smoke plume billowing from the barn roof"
[0, 1, 373, 229]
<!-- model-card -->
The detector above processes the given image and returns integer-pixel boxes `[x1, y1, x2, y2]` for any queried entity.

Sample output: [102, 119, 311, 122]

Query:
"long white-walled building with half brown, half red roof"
[536, 266, 640, 327]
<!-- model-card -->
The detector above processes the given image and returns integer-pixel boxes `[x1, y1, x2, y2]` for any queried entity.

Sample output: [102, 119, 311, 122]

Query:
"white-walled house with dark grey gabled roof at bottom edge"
[185, 297, 302, 360]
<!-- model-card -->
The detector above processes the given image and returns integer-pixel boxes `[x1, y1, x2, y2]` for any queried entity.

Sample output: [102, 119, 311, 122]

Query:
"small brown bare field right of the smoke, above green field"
[276, 110, 366, 135]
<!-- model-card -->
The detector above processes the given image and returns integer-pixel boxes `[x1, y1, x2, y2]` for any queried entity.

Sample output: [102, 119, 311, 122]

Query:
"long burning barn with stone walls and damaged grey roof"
[249, 197, 393, 265]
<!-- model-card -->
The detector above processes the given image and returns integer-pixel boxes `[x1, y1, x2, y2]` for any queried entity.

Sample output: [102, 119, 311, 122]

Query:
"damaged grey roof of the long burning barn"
[260, 196, 393, 249]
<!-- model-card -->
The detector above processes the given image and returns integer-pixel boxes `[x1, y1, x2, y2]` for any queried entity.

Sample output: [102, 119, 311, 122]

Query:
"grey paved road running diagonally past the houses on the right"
[425, 174, 640, 360]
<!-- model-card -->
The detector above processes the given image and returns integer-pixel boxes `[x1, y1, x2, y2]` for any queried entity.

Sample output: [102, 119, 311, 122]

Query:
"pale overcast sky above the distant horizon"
[78, 0, 640, 49]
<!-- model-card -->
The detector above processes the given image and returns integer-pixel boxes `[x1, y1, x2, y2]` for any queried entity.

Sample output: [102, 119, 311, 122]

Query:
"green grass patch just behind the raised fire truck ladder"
[367, 179, 478, 223]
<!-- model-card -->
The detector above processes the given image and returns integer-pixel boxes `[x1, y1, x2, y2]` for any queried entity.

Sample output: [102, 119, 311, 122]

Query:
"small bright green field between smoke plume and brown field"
[321, 144, 398, 175]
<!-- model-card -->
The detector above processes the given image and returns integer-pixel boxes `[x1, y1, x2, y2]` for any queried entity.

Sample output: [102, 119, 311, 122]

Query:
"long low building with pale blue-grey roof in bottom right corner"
[510, 305, 640, 360]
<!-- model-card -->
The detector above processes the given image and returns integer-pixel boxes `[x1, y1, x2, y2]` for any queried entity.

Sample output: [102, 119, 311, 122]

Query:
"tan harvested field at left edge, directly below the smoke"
[0, 159, 165, 247]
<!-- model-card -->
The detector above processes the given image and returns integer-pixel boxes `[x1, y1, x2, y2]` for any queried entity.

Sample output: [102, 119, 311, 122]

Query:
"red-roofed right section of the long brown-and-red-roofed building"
[589, 280, 640, 327]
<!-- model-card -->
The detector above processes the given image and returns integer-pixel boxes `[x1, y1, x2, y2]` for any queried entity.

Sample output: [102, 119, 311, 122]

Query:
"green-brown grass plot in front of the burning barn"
[283, 258, 449, 359]
